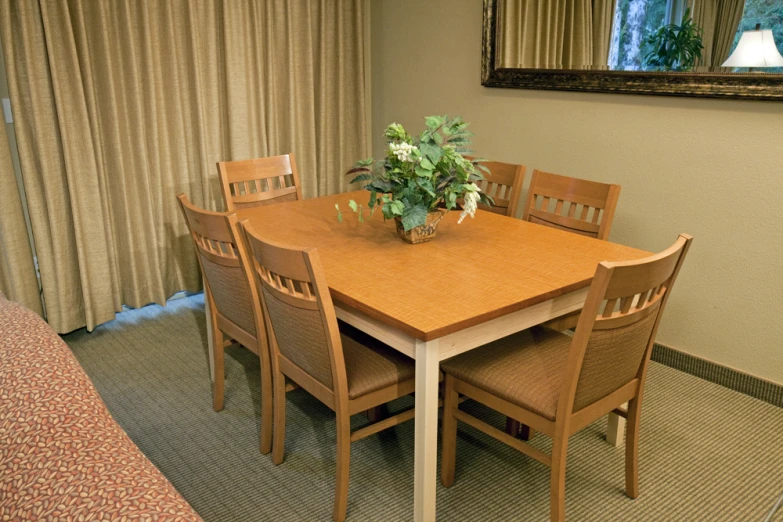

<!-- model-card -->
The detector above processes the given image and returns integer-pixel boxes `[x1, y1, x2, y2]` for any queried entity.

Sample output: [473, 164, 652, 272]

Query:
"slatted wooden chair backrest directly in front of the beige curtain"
[217, 153, 302, 211]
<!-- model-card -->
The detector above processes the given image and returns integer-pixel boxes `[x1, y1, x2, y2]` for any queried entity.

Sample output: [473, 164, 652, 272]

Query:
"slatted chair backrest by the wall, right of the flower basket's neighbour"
[522, 170, 620, 239]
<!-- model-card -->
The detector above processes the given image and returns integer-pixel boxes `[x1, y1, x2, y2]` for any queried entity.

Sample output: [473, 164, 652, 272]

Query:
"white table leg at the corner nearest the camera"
[413, 340, 440, 522]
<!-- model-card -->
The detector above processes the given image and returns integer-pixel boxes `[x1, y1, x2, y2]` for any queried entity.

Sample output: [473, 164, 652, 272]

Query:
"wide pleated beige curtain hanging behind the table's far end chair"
[0, 0, 366, 332]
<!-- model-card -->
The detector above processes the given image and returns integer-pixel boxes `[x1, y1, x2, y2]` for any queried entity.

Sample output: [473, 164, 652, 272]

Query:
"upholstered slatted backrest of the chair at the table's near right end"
[564, 234, 693, 412]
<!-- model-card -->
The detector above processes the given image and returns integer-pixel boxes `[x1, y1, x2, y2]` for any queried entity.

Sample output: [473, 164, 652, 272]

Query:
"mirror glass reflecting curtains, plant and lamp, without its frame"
[495, 0, 783, 73]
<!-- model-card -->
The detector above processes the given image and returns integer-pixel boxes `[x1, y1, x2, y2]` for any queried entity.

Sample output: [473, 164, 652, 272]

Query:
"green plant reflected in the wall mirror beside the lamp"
[644, 7, 704, 71]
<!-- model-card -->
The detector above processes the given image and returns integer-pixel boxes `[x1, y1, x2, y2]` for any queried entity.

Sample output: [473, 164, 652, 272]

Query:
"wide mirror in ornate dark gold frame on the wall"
[481, 0, 783, 100]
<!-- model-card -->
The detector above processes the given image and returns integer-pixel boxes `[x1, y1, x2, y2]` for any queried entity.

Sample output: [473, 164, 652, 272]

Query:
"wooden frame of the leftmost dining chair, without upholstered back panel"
[177, 194, 273, 454]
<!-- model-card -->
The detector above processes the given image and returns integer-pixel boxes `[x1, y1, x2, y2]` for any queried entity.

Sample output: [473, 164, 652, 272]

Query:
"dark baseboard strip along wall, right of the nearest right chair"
[651, 343, 783, 408]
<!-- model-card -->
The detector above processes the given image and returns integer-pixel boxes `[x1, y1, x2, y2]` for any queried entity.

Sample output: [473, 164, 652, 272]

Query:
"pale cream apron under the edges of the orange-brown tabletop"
[335, 288, 589, 361]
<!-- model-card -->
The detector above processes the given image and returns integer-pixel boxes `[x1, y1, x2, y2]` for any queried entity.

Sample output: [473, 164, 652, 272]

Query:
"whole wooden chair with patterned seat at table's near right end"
[441, 234, 692, 521]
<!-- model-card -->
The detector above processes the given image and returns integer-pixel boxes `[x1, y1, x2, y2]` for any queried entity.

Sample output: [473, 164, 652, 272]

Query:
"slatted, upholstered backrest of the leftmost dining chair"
[177, 194, 265, 344]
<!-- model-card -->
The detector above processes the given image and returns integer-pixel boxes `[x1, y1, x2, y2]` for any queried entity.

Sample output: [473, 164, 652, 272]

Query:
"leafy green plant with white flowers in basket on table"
[336, 116, 492, 243]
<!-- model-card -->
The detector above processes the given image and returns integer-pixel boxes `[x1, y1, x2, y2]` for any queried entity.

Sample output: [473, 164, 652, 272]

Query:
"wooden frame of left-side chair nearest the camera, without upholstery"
[240, 220, 415, 522]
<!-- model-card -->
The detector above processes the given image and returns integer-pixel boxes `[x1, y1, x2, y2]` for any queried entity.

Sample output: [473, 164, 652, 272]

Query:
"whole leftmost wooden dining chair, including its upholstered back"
[177, 194, 273, 454]
